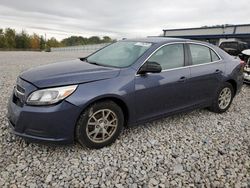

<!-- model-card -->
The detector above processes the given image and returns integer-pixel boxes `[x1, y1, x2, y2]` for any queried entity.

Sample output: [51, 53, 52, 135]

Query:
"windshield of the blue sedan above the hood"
[87, 41, 152, 68]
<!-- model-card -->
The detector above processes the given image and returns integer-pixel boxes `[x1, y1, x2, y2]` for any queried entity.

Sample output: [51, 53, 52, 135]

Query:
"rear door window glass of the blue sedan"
[189, 44, 211, 65]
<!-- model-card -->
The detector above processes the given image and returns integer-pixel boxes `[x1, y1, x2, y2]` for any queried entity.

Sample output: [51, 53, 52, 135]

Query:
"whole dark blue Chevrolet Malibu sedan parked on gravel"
[8, 37, 244, 148]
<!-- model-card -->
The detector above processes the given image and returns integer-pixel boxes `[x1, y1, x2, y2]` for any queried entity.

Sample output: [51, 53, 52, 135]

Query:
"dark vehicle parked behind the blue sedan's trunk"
[219, 41, 248, 56]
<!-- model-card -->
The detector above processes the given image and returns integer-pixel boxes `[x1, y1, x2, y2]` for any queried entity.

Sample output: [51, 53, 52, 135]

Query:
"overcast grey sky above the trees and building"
[0, 0, 250, 39]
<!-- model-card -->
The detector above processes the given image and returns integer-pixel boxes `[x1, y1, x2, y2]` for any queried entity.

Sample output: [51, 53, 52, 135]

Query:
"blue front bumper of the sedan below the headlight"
[7, 94, 81, 144]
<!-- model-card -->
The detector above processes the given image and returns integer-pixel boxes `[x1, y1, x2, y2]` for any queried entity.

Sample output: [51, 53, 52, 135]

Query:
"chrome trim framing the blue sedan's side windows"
[135, 41, 223, 76]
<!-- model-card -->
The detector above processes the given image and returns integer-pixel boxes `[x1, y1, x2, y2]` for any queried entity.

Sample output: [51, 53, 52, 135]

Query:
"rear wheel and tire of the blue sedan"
[209, 82, 235, 113]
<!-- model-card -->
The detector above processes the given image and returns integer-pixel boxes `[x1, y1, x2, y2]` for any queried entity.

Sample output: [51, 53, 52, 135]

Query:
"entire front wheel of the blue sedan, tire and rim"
[76, 100, 124, 149]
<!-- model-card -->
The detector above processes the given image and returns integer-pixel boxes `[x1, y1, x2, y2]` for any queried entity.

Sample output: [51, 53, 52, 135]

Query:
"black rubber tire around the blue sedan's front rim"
[76, 101, 124, 149]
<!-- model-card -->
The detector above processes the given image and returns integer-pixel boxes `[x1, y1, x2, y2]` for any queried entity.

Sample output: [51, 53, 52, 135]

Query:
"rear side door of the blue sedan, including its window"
[188, 44, 225, 105]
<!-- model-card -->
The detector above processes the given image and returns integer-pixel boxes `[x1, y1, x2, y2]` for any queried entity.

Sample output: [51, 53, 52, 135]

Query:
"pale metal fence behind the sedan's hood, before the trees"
[51, 43, 110, 53]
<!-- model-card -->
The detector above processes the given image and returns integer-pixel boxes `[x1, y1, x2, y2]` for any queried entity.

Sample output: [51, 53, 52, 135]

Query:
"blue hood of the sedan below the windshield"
[20, 59, 120, 88]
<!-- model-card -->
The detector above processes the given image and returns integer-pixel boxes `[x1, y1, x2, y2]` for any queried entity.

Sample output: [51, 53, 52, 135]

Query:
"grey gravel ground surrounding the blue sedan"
[0, 52, 250, 188]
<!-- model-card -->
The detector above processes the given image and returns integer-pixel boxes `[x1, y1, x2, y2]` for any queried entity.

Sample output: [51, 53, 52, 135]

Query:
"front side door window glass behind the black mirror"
[148, 44, 184, 70]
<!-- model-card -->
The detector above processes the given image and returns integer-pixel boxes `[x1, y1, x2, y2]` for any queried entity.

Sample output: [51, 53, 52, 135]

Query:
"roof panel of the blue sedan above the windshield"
[123, 37, 190, 43]
